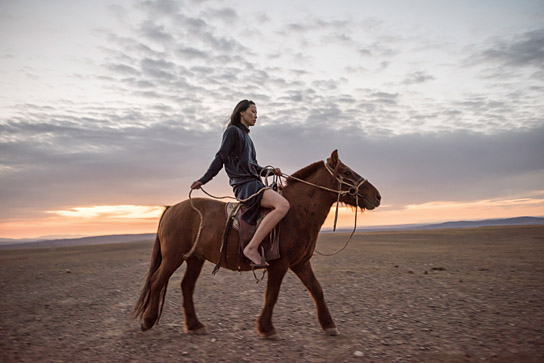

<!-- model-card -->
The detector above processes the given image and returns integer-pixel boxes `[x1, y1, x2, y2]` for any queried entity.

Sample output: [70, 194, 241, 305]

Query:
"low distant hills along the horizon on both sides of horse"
[0, 217, 544, 249]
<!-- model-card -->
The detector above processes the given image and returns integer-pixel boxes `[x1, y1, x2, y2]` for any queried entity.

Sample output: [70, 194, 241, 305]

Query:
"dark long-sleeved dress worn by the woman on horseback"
[199, 124, 265, 225]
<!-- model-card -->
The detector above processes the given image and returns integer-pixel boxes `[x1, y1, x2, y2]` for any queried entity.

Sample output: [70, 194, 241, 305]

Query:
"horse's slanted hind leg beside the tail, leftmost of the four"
[140, 258, 183, 331]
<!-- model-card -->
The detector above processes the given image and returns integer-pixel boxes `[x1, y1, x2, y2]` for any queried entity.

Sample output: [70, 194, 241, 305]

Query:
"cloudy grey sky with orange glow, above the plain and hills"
[0, 0, 544, 238]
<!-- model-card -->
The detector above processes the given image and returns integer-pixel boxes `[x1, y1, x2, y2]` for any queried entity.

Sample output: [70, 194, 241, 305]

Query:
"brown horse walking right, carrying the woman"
[134, 150, 381, 338]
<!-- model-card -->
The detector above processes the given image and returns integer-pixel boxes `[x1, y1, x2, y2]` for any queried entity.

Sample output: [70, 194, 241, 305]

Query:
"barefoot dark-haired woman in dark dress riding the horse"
[191, 100, 289, 268]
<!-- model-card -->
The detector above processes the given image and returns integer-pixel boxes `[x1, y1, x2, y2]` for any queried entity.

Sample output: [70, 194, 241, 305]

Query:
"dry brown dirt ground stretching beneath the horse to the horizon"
[0, 226, 544, 362]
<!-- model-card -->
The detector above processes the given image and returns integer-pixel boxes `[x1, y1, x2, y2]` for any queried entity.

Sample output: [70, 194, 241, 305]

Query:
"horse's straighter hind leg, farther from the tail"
[181, 256, 207, 334]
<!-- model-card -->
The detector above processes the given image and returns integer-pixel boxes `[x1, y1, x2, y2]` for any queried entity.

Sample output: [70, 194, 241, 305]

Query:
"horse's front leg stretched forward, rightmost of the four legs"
[291, 260, 338, 335]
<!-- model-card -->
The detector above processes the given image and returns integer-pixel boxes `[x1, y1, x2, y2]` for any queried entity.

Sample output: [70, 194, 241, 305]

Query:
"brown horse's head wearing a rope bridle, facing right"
[326, 150, 382, 210]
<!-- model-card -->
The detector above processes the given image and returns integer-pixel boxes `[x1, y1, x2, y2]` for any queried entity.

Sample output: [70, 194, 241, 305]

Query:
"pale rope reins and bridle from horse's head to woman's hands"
[183, 162, 367, 259]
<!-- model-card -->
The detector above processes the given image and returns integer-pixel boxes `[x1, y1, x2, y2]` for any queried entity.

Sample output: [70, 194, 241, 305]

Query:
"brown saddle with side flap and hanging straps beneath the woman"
[213, 203, 280, 274]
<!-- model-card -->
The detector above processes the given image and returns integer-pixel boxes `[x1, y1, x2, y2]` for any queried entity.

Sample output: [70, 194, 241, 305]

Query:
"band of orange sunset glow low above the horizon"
[0, 191, 544, 242]
